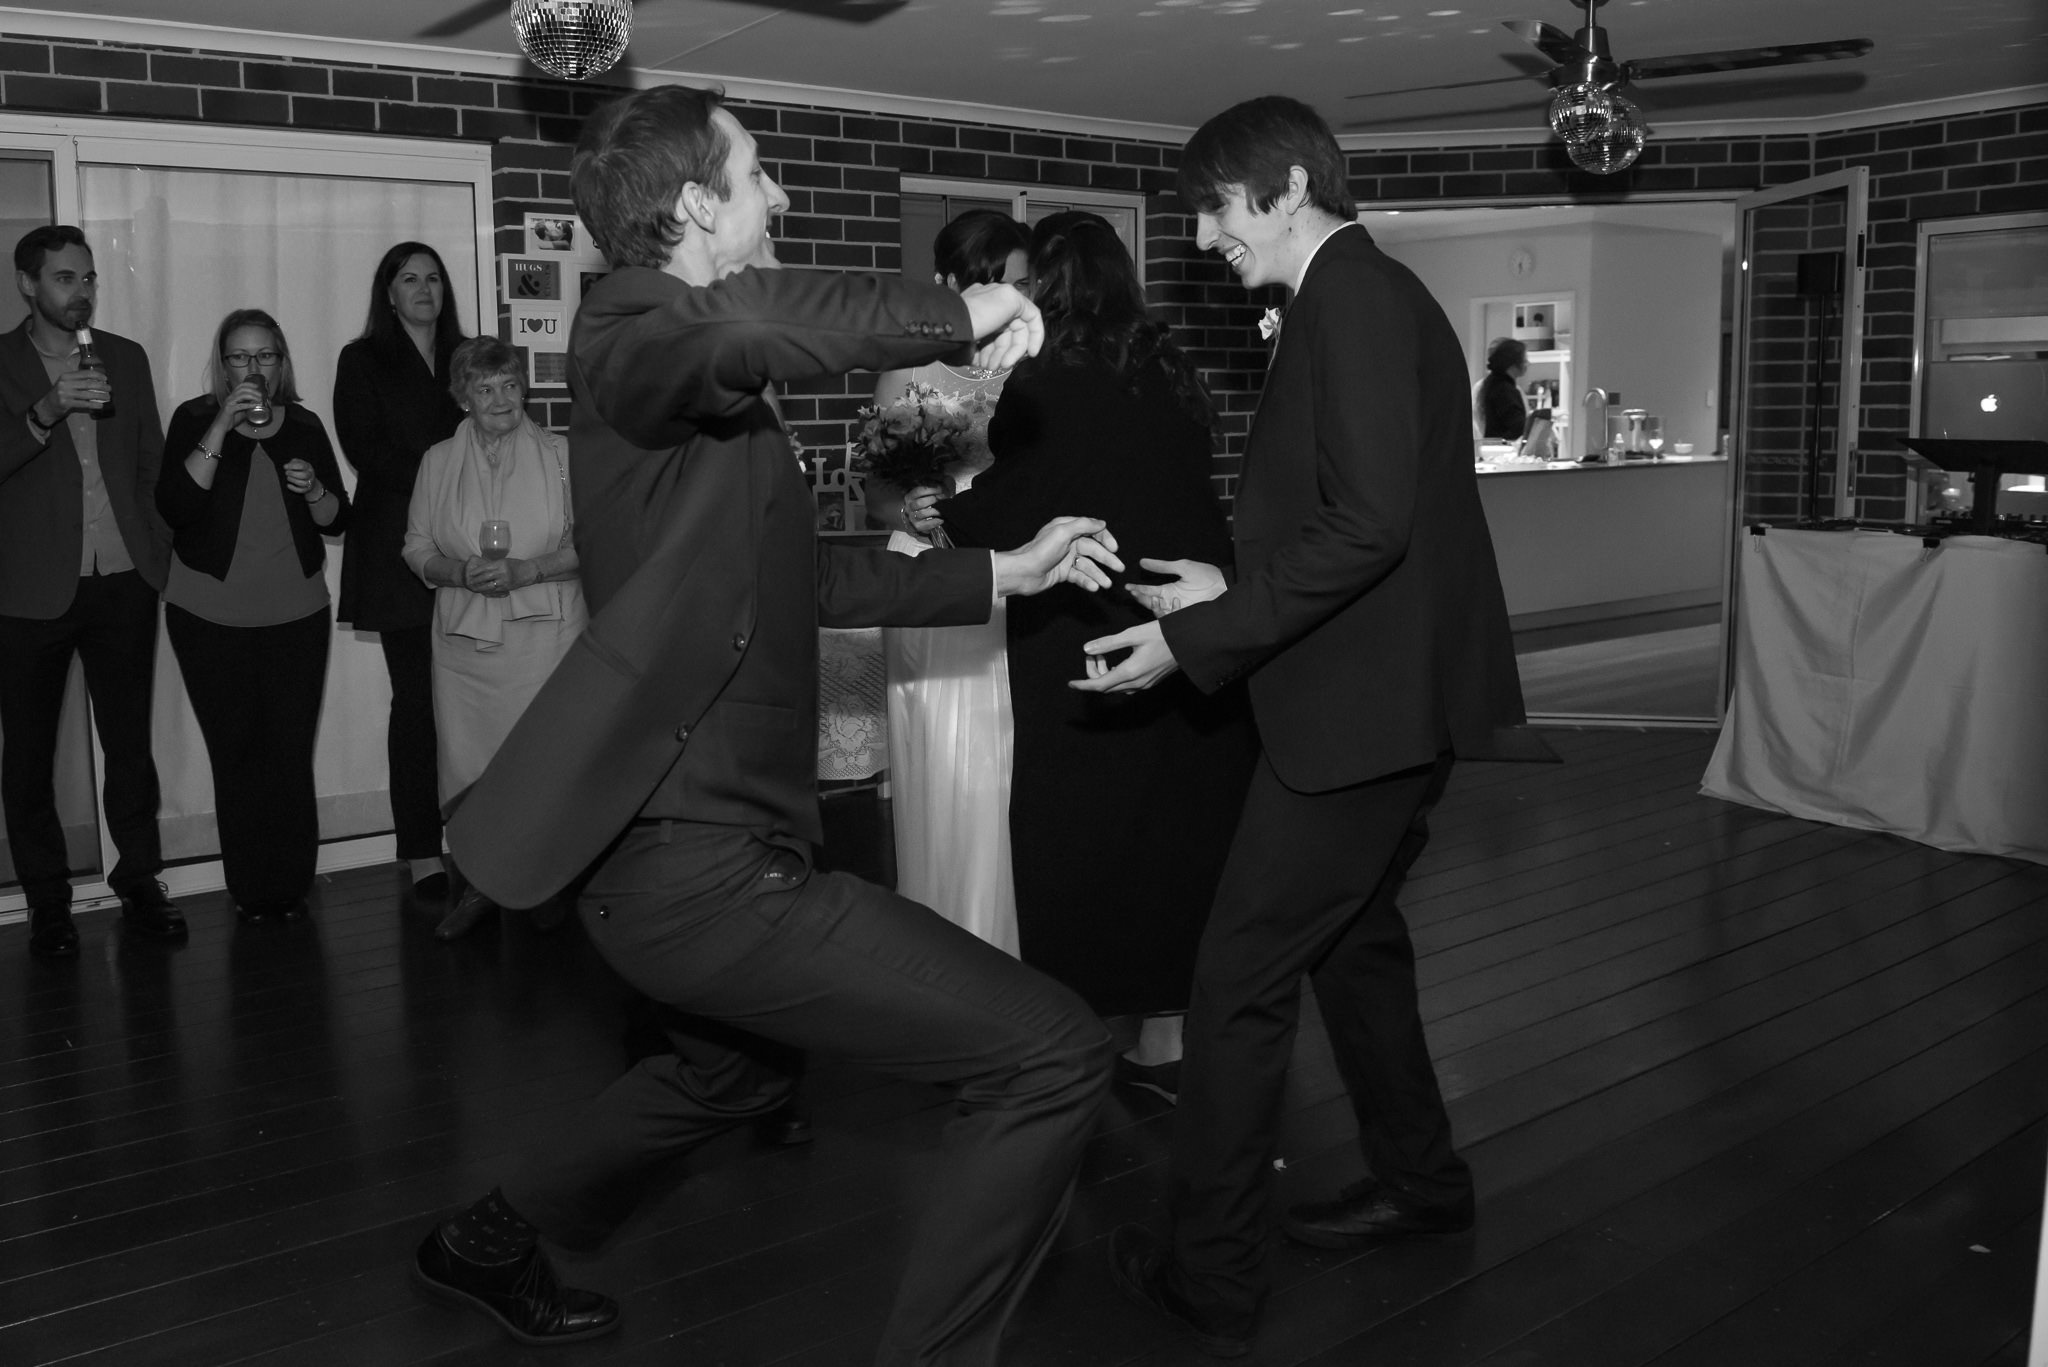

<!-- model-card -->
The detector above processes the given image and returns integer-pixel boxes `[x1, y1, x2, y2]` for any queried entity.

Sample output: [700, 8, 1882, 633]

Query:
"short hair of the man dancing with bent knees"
[569, 86, 733, 271]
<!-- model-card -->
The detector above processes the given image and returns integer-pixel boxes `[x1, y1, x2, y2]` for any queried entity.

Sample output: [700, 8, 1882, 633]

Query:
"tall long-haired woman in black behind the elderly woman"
[334, 242, 463, 900]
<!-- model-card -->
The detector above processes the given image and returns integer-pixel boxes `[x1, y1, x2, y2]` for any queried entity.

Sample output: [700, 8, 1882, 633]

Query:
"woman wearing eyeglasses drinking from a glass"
[156, 309, 348, 922]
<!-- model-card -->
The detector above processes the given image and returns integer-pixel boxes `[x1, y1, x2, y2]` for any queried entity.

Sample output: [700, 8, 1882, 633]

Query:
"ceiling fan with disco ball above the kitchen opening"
[1350, 0, 1876, 176]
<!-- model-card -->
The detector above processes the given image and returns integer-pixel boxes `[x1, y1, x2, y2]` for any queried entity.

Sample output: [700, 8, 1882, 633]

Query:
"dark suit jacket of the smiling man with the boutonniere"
[1161, 223, 1540, 793]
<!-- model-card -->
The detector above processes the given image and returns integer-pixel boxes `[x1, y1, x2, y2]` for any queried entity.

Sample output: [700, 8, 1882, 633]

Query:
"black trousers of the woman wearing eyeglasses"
[164, 603, 334, 908]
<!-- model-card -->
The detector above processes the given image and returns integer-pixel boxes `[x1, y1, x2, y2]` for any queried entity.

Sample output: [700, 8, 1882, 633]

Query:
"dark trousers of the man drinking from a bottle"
[0, 570, 164, 906]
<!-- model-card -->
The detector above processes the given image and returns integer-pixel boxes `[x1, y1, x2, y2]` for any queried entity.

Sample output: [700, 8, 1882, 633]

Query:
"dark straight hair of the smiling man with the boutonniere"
[1180, 94, 1358, 219]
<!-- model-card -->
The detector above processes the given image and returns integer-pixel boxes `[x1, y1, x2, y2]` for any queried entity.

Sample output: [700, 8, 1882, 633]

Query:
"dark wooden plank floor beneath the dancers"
[0, 732, 2048, 1367]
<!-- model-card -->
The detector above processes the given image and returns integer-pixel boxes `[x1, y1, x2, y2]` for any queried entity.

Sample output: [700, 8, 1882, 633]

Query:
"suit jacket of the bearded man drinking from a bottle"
[0, 322, 170, 621]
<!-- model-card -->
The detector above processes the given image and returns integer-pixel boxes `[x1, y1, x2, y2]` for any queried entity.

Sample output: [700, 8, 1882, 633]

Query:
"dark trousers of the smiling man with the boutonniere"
[1171, 754, 1473, 1316]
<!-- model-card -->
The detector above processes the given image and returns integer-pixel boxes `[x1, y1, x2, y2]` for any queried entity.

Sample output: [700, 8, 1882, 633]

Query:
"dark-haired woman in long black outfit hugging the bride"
[940, 211, 1255, 1096]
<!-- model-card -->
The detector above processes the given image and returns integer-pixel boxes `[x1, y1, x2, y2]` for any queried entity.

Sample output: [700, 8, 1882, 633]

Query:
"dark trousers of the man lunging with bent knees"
[504, 822, 1110, 1367]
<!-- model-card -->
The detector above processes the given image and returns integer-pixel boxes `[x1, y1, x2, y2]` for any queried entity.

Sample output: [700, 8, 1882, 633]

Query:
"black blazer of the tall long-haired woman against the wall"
[334, 332, 463, 631]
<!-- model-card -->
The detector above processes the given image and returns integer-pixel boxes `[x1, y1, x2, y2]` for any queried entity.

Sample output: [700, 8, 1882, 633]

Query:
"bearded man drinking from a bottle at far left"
[0, 223, 184, 959]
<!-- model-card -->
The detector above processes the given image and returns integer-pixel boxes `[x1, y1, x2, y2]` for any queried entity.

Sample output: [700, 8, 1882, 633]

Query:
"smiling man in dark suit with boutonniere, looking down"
[1075, 96, 1524, 1355]
